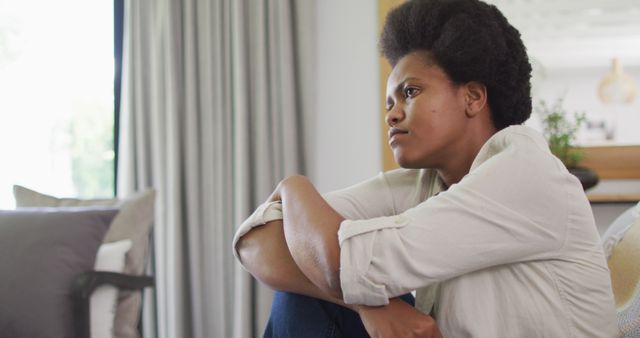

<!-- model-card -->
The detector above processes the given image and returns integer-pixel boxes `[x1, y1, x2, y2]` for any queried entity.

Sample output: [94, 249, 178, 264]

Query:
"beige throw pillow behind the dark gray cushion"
[13, 185, 155, 338]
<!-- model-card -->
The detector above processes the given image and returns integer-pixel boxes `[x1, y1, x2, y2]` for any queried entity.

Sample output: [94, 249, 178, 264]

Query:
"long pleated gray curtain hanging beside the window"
[118, 0, 308, 338]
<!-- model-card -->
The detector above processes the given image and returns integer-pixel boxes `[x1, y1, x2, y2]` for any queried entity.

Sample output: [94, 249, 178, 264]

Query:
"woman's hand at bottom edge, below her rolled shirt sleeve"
[356, 298, 442, 338]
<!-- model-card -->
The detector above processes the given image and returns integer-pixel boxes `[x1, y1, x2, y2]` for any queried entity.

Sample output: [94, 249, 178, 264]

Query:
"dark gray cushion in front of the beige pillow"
[0, 208, 117, 338]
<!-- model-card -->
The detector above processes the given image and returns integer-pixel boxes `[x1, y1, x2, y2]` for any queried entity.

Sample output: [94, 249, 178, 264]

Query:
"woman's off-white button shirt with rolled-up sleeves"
[234, 126, 616, 338]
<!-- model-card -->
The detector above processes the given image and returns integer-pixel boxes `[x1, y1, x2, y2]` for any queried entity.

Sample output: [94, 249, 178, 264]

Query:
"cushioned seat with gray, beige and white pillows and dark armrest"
[0, 186, 155, 338]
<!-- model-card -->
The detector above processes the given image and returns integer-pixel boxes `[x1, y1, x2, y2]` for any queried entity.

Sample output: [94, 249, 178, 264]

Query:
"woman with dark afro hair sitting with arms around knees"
[234, 0, 615, 337]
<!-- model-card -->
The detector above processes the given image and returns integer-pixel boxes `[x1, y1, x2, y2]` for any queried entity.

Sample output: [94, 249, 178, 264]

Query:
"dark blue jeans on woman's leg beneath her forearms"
[263, 292, 415, 338]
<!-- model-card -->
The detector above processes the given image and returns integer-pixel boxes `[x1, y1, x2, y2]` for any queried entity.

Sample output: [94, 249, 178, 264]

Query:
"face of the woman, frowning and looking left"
[386, 52, 468, 169]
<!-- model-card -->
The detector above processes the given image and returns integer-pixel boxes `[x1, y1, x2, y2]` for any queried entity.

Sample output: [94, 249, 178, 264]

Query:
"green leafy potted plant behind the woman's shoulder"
[535, 99, 598, 190]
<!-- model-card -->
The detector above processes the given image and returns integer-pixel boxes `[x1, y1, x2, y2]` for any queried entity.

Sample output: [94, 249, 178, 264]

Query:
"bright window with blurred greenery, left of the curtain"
[0, 0, 114, 208]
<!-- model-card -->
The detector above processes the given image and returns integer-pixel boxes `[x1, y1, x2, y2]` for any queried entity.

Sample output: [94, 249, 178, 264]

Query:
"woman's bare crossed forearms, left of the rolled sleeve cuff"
[236, 176, 376, 303]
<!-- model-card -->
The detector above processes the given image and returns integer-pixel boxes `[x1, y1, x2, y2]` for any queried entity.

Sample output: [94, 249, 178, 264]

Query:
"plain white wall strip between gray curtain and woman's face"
[306, 0, 382, 192]
